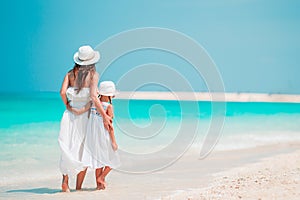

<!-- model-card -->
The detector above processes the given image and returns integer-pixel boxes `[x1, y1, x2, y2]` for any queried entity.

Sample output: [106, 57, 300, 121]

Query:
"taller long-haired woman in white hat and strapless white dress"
[58, 46, 111, 192]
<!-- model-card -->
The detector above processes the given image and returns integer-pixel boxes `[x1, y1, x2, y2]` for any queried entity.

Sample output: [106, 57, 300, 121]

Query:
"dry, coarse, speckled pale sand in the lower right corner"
[163, 145, 300, 200]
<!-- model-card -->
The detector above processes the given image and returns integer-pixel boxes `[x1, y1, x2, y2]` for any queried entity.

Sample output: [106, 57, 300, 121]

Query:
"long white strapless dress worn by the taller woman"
[58, 87, 90, 176]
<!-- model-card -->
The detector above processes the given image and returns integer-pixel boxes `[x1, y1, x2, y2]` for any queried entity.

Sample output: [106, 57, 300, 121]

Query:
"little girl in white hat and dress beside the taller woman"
[82, 81, 120, 190]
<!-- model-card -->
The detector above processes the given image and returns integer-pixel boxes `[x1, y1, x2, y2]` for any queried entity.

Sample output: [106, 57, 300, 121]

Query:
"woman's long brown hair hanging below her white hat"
[76, 64, 96, 94]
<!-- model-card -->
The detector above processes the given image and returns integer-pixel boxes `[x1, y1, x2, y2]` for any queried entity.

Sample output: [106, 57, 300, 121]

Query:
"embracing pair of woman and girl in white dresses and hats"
[58, 46, 120, 192]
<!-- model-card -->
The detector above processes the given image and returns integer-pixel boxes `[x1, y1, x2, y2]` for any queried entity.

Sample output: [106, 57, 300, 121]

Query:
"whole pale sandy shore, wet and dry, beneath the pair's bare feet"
[0, 143, 300, 199]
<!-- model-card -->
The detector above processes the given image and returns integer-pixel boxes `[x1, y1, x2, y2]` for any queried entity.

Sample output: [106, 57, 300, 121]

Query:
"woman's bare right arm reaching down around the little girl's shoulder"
[90, 72, 112, 130]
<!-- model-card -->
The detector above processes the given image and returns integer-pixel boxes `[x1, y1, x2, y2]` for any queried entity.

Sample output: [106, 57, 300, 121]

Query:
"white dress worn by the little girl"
[82, 102, 121, 169]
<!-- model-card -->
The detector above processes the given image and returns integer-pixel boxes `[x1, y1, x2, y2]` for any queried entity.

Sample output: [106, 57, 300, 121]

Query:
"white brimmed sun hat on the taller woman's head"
[74, 45, 100, 65]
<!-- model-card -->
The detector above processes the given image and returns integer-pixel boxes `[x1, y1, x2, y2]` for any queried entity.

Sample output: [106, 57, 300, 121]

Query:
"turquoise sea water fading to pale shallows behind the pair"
[0, 93, 300, 186]
